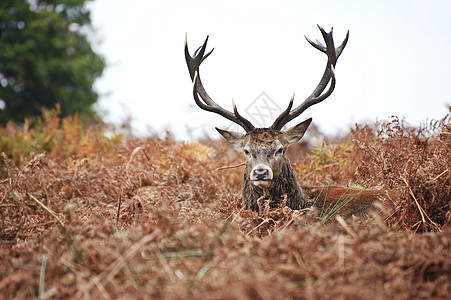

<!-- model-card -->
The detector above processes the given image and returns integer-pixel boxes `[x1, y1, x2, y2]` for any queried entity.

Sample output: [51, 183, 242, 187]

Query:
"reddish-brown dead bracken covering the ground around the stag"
[0, 107, 451, 299]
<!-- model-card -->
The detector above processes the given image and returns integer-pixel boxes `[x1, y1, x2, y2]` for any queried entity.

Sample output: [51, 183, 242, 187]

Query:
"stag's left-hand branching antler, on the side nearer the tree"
[185, 36, 255, 132]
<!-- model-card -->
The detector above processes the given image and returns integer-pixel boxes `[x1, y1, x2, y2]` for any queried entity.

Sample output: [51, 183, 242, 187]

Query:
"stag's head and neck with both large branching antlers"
[185, 26, 349, 210]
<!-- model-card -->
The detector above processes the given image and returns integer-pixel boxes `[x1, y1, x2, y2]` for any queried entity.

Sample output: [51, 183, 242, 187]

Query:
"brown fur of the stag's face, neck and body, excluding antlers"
[220, 124, 393, 217]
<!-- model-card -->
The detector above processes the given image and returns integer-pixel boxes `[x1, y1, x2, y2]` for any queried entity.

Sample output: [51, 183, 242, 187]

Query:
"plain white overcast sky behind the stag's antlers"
[89, 0, 451, 140]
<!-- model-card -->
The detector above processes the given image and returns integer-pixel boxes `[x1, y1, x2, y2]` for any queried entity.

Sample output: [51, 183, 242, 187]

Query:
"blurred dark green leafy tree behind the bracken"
[0, 0, 105, 124]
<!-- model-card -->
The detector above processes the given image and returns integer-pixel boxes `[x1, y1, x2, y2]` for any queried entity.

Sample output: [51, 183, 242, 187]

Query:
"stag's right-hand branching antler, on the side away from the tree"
[271, 25, 349, 130]
